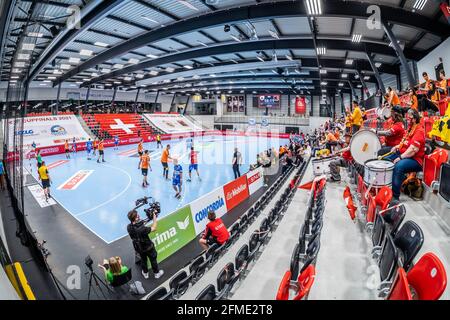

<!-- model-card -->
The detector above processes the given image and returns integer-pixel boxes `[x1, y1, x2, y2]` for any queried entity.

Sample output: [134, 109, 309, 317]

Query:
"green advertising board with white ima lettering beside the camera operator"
[150, 205, 196, 262]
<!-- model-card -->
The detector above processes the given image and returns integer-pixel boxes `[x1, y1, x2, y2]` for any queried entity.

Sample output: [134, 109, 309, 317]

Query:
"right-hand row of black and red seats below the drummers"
[348, 169, 447, 300]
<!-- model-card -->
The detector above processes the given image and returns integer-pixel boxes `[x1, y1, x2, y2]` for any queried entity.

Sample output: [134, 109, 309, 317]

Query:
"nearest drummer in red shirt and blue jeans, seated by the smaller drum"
[385, 109, 425, 200]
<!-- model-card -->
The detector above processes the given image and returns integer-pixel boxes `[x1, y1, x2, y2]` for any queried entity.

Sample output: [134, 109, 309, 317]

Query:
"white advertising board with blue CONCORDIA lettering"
[191, 187, 227, 234]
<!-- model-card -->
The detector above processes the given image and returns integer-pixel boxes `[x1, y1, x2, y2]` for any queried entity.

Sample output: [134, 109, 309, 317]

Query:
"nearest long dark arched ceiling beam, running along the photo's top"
[53, 0, 450, 85]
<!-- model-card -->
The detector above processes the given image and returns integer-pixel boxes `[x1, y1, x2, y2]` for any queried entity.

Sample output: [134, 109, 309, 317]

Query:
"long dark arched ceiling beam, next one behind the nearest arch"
[79, 39, 414, 86]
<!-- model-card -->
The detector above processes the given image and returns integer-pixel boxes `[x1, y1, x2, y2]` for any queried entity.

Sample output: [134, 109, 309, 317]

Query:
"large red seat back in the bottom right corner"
[407, 252, 447, 300]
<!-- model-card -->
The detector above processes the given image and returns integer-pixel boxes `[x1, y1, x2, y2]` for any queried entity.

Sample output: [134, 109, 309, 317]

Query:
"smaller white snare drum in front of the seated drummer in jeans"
[364, 160, 394, 187]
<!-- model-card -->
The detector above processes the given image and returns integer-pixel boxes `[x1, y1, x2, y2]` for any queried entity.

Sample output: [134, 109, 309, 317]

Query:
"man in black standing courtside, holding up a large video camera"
[127, 209, 164, 279]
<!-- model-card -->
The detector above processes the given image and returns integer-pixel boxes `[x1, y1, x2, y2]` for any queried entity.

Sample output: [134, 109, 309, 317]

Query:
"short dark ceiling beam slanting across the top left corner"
[29, 0, 131, 81]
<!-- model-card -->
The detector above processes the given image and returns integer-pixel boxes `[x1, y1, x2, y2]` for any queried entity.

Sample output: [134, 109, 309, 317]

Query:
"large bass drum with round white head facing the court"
[350, 130, 381, 165]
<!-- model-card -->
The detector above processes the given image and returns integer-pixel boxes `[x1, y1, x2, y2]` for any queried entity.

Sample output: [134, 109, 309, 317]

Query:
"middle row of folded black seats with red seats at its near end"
[276, 179, 326, 300]
